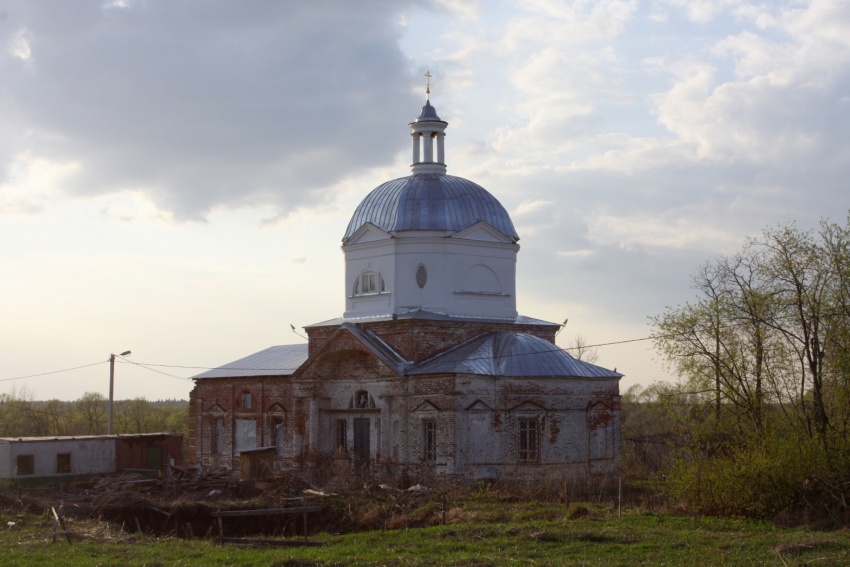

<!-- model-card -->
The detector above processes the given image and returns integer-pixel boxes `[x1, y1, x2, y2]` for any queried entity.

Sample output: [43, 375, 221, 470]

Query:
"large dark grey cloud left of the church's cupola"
[0, 0, 419, 219]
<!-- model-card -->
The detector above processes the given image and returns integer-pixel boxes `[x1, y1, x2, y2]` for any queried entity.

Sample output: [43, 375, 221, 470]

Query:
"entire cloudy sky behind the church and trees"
[0, 0, 850, 400]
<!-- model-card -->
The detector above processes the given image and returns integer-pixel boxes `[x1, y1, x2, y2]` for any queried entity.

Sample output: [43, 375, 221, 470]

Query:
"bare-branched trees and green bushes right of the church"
[622, 217, 850, 524]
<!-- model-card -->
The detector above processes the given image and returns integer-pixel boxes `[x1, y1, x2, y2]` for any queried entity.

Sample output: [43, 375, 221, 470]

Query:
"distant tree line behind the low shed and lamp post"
[0, 388, 189, 437]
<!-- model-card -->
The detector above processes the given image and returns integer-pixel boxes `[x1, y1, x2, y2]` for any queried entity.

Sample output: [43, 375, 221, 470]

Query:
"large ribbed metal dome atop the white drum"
[343, 173, 519, 242]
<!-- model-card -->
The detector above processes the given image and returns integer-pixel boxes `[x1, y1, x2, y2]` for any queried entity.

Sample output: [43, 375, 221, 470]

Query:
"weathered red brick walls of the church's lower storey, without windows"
[189, 320, 620, 481]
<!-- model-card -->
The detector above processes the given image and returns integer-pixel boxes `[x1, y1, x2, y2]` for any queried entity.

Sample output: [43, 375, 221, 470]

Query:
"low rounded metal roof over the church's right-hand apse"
[407, 331, 623, 378]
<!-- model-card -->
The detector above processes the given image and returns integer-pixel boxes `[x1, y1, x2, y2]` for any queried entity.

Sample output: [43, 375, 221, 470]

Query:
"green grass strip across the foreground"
[0, 505, 850, 567]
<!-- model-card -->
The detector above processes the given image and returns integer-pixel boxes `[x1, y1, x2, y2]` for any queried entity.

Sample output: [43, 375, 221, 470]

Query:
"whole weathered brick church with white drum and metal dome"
[189, 92, 622, 480]
